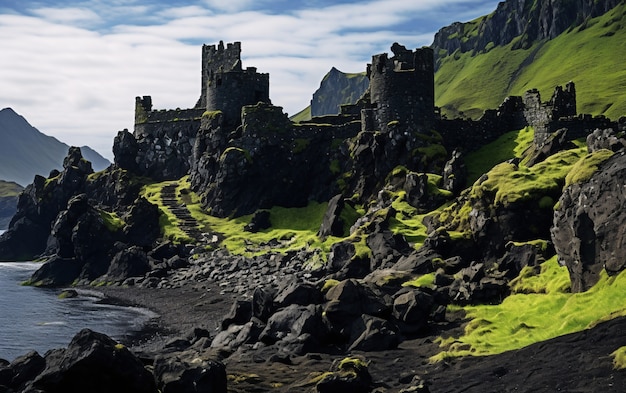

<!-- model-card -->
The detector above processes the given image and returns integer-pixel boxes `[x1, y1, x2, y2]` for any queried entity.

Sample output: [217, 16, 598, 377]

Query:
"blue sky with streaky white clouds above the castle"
[0, 0, 498, 159]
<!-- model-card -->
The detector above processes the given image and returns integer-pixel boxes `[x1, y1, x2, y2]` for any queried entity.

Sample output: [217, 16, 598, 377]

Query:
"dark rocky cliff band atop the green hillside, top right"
[432, 0, 620, 61]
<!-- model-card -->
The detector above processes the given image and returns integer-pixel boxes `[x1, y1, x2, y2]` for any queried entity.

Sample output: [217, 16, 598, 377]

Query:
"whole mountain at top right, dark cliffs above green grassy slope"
[432, 0, 626, 118]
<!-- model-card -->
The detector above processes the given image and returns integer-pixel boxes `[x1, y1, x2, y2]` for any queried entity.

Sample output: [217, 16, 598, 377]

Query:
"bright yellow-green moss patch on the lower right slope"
[431, 256, 626, 361]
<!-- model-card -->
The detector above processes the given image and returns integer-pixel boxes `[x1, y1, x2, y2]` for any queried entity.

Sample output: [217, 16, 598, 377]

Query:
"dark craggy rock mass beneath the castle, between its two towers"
[191, 103, 358, 217]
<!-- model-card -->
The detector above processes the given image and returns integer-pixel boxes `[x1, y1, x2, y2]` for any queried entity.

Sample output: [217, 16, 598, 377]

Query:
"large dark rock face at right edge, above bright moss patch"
[551, 151, 626, 292]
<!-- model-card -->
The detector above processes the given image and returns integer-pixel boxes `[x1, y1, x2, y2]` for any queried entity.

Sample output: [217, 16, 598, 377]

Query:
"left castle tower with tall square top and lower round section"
[196, 41, 270, 124]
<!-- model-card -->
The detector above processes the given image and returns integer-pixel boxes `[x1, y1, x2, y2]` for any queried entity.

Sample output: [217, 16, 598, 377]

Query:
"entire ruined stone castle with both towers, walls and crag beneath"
[114, 42, 617, 216]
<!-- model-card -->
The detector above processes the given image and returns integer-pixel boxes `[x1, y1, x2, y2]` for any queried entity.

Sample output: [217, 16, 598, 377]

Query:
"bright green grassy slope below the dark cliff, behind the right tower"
[435, 4, 626, 119]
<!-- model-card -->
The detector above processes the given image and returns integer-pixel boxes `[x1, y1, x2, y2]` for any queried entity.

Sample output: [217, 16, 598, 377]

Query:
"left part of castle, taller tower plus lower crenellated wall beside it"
[127, 42, 270, 180]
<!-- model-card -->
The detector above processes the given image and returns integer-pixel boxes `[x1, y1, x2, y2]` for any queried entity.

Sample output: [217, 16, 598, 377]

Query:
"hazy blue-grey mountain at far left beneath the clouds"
[0, 108, 110, 186]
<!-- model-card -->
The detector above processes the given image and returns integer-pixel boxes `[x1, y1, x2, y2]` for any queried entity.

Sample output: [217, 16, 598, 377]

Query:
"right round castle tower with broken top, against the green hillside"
[364, 43, 435, 132]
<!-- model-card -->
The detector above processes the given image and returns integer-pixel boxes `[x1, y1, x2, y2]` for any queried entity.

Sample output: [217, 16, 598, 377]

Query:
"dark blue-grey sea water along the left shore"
[0, 254, 156, 361]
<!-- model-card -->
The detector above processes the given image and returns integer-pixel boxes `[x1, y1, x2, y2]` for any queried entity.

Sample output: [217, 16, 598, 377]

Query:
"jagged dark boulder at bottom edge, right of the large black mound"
[154, 353, 227, 393]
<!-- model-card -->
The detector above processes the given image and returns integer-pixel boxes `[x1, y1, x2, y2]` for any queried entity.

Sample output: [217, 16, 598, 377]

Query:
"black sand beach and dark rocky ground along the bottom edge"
[0, 278, 626, 393]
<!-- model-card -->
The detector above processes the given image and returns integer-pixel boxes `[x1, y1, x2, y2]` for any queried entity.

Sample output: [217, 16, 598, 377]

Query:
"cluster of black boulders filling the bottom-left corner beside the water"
[0, 329, 226, 393]
